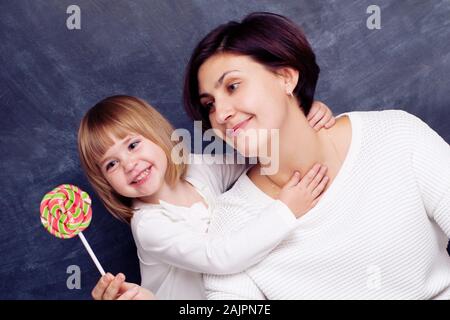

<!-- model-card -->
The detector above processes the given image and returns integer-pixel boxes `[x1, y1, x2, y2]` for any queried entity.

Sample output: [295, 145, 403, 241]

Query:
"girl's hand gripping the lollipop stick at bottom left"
[92, 273, 155, 300]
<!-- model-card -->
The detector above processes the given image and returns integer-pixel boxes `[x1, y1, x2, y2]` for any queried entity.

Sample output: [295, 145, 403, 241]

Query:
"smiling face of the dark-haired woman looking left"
[198, 53, 293, 157]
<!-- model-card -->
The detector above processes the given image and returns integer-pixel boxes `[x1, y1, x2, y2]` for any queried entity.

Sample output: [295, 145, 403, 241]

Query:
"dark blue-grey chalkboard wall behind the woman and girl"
[0, 0, 450, 299]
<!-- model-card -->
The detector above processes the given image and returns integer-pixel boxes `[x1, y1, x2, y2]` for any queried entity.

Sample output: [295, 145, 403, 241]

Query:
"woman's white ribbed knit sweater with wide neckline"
[205, 110, 450, 299]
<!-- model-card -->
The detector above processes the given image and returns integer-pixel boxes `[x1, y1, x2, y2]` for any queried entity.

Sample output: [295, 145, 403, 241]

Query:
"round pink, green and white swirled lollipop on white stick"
[40, 184, 105, 275]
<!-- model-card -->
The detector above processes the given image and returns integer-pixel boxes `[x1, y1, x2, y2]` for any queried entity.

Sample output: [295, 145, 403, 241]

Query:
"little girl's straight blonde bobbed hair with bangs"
[78, 95, 187, 223]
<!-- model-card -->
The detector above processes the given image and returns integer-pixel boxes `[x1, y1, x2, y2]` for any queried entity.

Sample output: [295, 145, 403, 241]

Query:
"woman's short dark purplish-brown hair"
[183, 12, 320, 130]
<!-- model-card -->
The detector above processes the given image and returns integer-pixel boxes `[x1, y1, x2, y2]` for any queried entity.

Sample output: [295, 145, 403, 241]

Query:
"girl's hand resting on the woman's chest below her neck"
[278, 164, 329, 218]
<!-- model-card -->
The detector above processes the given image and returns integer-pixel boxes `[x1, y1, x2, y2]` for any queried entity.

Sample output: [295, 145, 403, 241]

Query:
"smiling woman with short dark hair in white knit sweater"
[185, 13, 450, 299]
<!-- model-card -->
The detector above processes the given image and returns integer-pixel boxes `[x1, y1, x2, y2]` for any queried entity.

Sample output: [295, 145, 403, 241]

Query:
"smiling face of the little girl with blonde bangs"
[99, 134, 167, 198]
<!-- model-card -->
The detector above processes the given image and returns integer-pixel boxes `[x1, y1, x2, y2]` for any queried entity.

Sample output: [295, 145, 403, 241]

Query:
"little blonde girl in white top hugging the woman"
[78, 96, 334, 299]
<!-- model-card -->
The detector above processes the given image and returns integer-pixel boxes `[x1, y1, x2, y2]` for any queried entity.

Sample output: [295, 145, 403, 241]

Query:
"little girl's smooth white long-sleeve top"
[131, 154, 296, 299]
